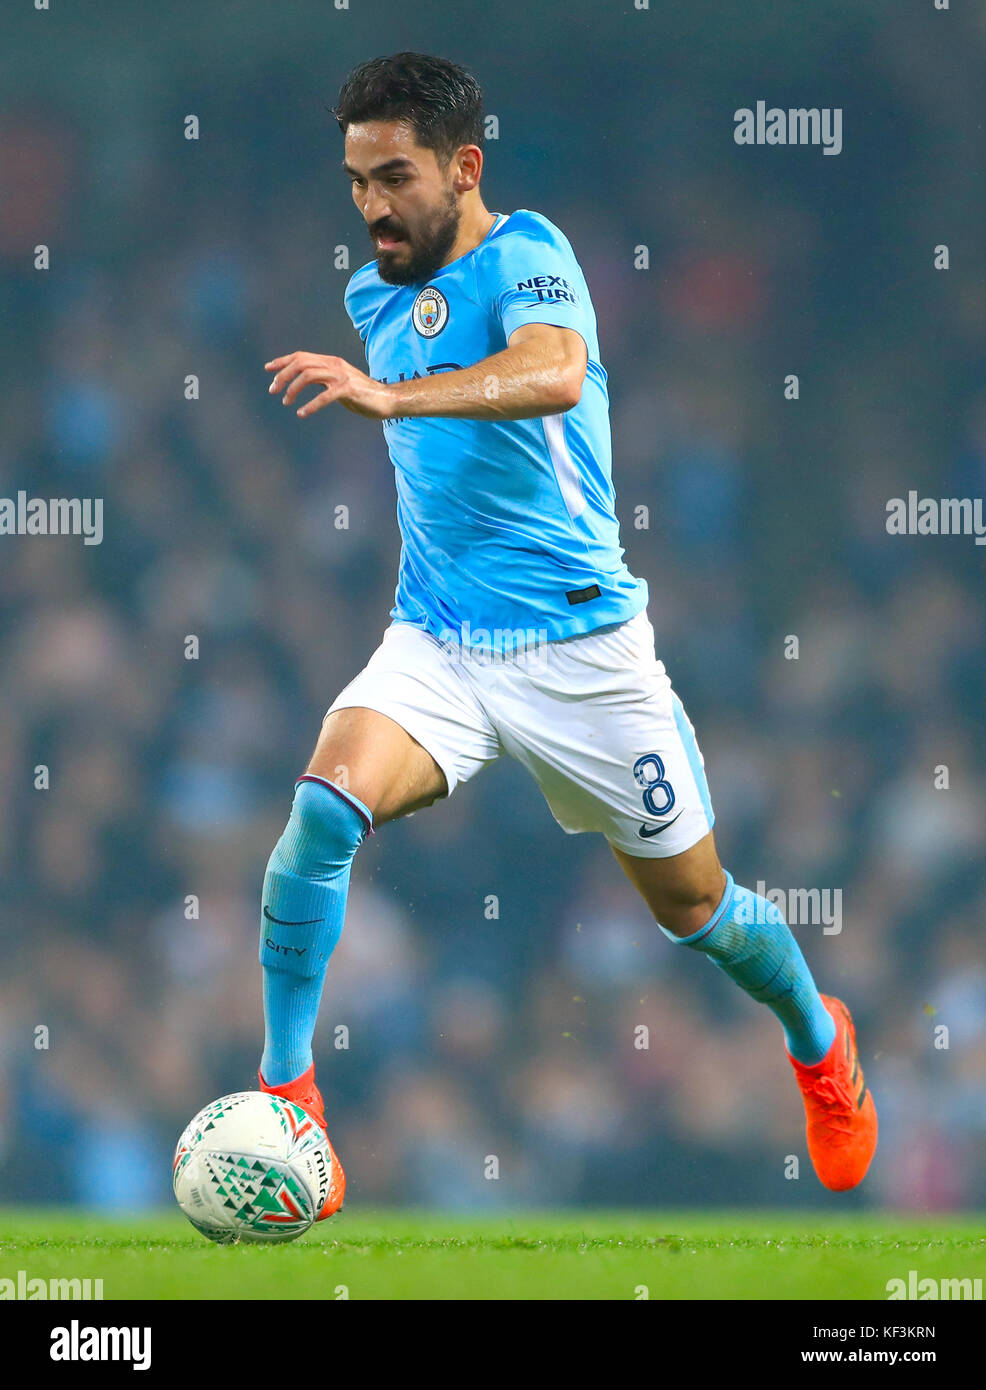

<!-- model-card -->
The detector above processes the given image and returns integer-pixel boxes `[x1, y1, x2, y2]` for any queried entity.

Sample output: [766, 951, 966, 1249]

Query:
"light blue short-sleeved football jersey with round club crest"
[346, 211, 647, 651]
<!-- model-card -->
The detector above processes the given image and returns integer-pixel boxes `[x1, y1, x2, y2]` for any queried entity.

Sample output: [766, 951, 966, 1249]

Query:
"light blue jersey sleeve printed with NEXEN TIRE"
[480, 218, 590, 350]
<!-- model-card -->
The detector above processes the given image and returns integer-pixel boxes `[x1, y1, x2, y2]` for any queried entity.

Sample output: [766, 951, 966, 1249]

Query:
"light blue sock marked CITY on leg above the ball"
[260, 774, 373, 1086]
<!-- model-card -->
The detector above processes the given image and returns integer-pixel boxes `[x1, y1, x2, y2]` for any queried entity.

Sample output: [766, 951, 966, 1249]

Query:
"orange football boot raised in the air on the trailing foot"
[789, 994, 876, 1193]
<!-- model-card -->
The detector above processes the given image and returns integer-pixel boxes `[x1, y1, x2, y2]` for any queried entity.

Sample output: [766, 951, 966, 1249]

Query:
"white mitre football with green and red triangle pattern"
[172, 1091, 332, 1245]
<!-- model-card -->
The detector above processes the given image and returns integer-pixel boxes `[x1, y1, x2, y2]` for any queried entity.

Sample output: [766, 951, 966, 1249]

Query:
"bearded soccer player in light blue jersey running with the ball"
[260, 53, 876, 1218]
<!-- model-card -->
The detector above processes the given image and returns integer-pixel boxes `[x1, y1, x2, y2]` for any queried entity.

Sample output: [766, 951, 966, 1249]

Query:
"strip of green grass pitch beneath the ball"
[0, 1207, 986, 1300]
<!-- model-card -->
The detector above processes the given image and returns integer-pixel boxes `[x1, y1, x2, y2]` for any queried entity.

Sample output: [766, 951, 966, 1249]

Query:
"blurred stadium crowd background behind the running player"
[0, 0, 986, 1211]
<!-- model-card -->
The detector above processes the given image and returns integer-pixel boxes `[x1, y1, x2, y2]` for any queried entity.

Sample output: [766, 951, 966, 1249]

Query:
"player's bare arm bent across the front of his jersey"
[266, 324, 587, 420]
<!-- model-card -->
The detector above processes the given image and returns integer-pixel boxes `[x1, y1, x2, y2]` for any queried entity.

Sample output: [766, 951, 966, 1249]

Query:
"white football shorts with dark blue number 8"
[328, 613, 715, 859]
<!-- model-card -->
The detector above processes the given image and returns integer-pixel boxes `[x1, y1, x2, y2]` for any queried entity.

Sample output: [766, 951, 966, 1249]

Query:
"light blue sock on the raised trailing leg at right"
[661, 873, 836, 1066]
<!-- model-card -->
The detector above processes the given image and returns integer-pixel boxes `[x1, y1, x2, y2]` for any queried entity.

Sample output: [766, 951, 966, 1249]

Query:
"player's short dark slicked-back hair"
[332, 53, 483, 164]
